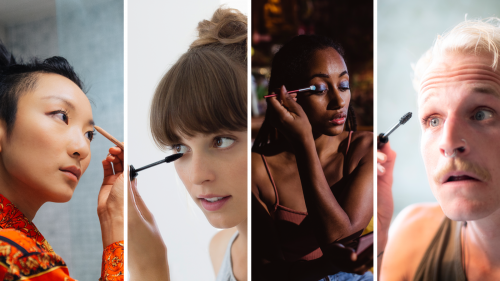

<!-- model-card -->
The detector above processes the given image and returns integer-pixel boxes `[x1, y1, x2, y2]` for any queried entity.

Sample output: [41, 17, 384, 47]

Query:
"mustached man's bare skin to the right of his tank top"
[465, 209, 500, 268]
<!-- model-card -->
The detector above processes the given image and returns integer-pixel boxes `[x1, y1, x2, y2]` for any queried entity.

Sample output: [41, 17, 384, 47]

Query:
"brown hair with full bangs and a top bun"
[150, 8, 247, 149]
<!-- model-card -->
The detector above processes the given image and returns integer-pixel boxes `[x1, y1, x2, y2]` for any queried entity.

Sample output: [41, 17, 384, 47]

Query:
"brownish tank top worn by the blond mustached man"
[413, 217, 467, 281]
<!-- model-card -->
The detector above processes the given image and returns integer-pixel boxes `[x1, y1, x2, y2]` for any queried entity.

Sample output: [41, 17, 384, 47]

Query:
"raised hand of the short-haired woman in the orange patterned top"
[97, 147, 124, 248]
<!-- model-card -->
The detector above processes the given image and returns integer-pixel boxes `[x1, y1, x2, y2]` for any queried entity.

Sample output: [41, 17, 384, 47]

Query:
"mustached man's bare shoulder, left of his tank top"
[380, 203, 444, 280]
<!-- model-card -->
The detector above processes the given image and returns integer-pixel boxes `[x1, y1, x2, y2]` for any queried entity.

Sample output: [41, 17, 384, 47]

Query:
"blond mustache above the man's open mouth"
[434, 157, 491, 184]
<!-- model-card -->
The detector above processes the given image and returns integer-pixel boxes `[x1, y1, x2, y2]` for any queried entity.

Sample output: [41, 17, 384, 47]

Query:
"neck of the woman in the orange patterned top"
[0, 161, 45, 221]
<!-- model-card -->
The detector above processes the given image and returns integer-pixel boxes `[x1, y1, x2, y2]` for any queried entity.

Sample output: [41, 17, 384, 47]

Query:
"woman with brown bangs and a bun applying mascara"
[129, 8, 247, 280]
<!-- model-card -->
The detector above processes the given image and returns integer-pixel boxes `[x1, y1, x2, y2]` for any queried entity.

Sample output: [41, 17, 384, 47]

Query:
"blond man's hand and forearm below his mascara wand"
[376, 140, 396, 272]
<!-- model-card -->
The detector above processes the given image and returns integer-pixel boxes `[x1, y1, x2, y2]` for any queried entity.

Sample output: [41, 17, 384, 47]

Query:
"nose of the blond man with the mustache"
[439, 117, 470, 158]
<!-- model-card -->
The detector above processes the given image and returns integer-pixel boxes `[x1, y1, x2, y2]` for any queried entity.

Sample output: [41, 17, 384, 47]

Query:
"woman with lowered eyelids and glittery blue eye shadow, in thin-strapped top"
[252, 35, 373, 280]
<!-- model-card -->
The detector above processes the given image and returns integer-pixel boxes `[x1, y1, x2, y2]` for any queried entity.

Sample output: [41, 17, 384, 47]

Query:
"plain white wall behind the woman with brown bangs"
[126, 0, 248, 280]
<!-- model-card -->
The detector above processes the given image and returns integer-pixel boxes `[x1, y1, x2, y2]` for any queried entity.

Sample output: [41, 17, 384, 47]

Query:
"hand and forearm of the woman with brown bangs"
[127, 176, 170, 281]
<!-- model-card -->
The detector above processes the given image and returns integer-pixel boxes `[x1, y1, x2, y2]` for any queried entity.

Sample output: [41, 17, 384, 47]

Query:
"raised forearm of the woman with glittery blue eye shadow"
[294, 138, 352, 245]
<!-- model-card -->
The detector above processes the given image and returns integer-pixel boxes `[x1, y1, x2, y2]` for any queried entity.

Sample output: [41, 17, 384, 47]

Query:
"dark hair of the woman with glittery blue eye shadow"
[252, 35, 357, 150]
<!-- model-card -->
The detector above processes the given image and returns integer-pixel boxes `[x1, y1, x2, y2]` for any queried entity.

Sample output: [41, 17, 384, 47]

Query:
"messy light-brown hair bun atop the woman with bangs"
[190, 8, 247, 62]
